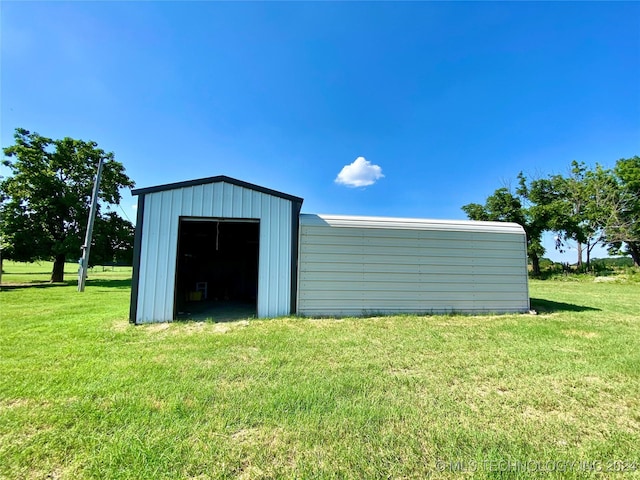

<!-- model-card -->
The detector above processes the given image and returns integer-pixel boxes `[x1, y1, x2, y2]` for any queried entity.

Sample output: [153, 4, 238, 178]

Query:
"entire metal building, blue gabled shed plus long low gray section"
[130, 176, 529, 323]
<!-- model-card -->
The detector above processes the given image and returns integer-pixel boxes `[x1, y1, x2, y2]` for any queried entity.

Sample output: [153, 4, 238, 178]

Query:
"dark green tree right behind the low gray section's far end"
[462, 188, 544, 275]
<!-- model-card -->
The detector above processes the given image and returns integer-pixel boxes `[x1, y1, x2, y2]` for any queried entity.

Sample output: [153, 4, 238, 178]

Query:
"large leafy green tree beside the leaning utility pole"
[0, 128, 134, 282]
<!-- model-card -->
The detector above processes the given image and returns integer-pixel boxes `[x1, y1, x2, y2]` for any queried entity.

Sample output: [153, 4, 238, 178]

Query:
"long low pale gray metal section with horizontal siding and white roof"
[298, 215, 529, 315]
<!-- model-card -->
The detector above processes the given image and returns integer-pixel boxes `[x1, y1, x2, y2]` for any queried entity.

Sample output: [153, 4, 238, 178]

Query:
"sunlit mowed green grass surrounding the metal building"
[0, 262, 640, 479]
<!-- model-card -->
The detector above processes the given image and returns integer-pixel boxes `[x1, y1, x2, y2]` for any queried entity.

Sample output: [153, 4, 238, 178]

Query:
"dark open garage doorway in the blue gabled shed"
[174, 217, 260, 321]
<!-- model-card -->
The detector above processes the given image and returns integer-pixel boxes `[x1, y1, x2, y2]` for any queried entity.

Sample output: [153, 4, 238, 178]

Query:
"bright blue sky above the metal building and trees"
[0, 1, 640, 261]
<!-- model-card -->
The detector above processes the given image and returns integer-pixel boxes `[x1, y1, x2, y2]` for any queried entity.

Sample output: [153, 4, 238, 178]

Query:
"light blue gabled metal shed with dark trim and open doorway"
[129, 176, 303, 323]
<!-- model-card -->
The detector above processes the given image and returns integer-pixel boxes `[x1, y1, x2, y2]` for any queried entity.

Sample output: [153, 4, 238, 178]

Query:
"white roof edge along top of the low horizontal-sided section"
[300, 213, 525, 235]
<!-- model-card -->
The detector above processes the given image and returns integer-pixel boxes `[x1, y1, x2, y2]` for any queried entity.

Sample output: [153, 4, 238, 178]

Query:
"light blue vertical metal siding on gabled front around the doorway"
[136, 182, 292, 323]
